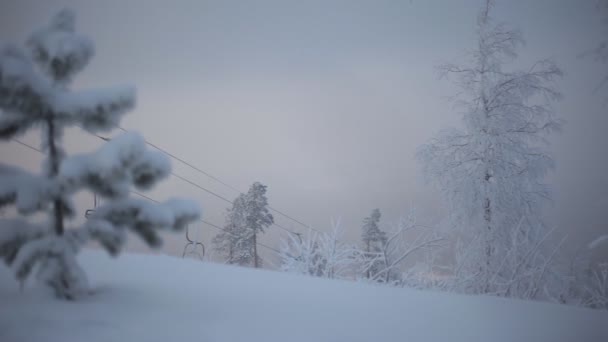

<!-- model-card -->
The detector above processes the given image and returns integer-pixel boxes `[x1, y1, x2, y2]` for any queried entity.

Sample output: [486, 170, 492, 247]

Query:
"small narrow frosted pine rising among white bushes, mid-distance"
[361, 209, 386, 279]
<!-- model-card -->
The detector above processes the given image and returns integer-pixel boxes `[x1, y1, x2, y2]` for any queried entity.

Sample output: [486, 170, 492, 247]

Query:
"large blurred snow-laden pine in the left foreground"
[0, 10, 199, 299]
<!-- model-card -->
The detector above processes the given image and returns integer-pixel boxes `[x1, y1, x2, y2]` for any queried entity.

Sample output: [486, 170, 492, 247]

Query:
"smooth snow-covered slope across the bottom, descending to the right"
[0, 251, 608, 342]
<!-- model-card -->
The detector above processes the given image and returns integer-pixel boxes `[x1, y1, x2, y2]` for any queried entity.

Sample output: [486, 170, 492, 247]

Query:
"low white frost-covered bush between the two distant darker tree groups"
[280, 220, 362, 279]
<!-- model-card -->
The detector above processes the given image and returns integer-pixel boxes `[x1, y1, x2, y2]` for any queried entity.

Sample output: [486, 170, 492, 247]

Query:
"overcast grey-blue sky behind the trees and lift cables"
[0, 0, 608, 260]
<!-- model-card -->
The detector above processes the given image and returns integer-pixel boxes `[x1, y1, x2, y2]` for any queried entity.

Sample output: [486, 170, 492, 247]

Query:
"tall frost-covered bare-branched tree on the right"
[418, 1, 562, 292]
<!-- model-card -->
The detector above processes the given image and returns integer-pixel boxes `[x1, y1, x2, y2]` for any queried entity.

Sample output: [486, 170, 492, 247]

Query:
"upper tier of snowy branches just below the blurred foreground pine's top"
[0, 45, 135, 139]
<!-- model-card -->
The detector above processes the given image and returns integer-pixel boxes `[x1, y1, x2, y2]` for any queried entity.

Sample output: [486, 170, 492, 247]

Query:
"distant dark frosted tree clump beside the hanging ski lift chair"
[213, 182, 274, 268]
